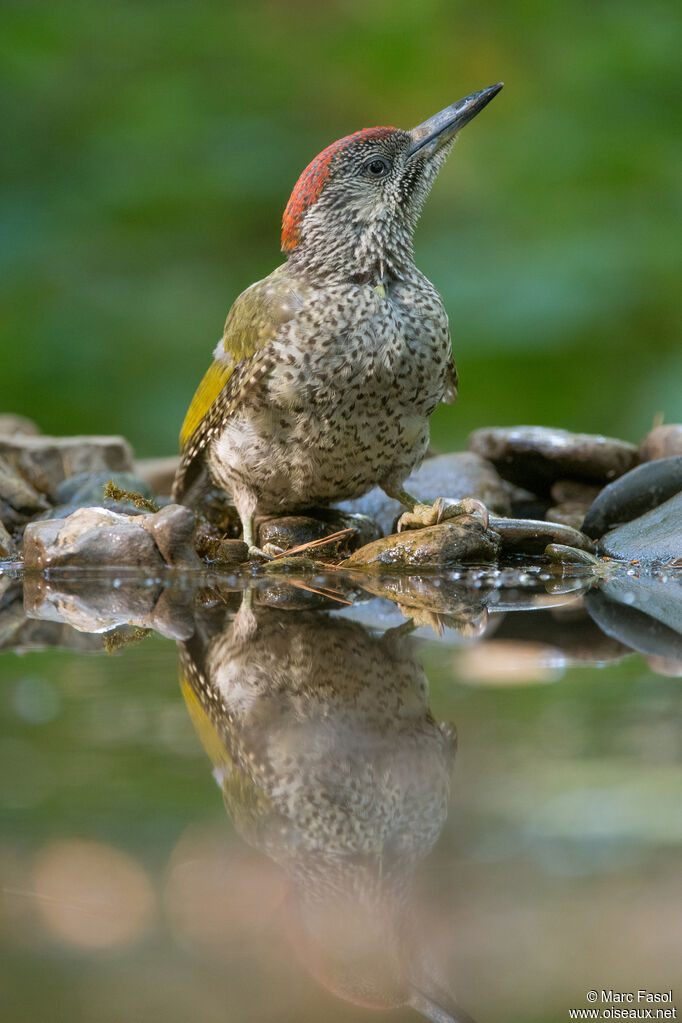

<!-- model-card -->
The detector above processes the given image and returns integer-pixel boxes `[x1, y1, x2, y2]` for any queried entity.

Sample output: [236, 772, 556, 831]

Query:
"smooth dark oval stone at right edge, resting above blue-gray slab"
[583, 455, 682, 539]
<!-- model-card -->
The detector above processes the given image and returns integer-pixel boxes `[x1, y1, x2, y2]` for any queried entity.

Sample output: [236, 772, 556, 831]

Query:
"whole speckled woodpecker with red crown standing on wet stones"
[173, 83, 502, 554]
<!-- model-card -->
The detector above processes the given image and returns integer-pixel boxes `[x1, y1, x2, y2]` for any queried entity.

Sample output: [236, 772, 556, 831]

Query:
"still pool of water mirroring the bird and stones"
[0, 565, 682, 1023]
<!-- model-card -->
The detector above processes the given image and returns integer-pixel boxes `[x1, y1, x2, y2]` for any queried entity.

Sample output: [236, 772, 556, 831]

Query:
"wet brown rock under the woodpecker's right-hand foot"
[343, 516, 500, 572]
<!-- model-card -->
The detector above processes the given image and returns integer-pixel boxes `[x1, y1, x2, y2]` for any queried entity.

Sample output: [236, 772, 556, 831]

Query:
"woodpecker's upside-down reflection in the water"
[180, 597, 470, 1023]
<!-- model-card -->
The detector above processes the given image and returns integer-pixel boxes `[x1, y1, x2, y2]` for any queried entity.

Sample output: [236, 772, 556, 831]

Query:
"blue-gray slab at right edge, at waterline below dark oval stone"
[598, 493, 682, 566]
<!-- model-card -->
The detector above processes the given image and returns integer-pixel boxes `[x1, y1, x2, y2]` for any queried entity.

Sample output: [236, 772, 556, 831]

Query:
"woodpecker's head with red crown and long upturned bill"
[282, 84, 502, 279]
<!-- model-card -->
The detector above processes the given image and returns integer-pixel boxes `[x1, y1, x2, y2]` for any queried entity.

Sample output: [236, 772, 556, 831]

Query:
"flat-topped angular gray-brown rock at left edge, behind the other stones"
[0, 434, 133, 502]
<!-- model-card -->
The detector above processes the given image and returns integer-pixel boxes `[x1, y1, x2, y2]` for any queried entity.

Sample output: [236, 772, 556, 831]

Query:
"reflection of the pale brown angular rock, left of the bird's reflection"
[24, 575, 194, 639]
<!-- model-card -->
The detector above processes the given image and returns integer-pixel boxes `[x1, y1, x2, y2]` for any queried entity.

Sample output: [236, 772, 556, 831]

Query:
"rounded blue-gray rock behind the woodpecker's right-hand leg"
[338, 451, 510, 534]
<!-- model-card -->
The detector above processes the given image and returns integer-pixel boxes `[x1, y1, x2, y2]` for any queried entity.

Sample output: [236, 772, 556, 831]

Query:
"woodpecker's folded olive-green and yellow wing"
[173, 264, 307, 500]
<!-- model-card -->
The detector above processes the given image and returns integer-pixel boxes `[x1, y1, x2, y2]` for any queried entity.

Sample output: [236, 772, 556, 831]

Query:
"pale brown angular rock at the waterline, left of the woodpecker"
[24, 504, 200, 572]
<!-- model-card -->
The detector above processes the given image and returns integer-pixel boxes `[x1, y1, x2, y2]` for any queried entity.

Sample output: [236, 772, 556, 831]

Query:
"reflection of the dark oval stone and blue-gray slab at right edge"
[585, 579, 682, 661]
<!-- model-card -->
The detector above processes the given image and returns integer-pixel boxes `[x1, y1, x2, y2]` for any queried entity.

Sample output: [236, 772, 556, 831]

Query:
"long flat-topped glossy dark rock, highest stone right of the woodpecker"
[468, 427, 638, 493]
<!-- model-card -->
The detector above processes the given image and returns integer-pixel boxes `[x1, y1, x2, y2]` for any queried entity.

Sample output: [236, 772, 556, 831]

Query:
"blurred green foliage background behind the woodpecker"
[0, 0, 682, 455]
